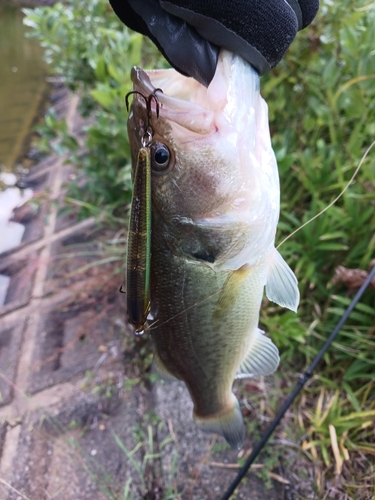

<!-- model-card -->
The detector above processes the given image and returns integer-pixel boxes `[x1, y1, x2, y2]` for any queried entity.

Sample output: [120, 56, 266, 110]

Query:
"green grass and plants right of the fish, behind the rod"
[262, 0, 375, 492]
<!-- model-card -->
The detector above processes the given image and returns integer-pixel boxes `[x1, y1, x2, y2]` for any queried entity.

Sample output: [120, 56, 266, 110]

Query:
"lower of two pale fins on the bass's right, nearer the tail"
[236, 328, 280, 378]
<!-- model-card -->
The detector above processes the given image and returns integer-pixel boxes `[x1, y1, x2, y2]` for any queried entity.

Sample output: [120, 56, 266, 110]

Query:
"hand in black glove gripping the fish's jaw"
[109, 0, 319, 86]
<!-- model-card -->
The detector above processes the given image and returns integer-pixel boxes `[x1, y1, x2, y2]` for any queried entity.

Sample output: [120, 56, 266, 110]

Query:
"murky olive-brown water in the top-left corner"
[0, 0, 47, 171]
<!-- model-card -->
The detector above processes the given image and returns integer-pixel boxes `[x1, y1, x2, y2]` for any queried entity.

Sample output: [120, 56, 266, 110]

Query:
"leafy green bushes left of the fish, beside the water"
[24, 0, 165, 217]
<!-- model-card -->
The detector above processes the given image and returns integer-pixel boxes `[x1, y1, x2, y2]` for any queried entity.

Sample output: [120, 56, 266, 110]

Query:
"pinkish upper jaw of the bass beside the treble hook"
[131, 67, 215, 135]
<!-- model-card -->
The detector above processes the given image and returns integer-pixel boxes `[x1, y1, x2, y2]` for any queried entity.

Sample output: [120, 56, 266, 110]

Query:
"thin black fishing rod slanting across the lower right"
[221, 266, 375, 500]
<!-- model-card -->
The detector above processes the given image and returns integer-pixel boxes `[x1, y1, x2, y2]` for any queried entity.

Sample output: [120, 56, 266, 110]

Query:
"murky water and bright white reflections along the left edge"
[0, 0, 47, 306]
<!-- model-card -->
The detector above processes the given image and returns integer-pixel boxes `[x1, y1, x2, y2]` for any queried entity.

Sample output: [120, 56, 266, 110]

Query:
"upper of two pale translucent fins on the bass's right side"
[266, 249, 299, 312]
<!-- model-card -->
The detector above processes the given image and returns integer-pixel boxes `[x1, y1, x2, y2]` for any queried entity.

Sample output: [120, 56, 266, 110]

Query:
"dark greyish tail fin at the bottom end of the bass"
[194, 394, 245, 450]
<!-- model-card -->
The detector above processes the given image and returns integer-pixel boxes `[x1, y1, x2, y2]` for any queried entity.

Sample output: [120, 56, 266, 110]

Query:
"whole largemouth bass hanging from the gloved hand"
[128, 50, 299, 448]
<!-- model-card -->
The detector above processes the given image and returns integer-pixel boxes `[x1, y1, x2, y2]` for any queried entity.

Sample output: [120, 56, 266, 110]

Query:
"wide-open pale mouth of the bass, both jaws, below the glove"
[131, 50, 260, 135]
